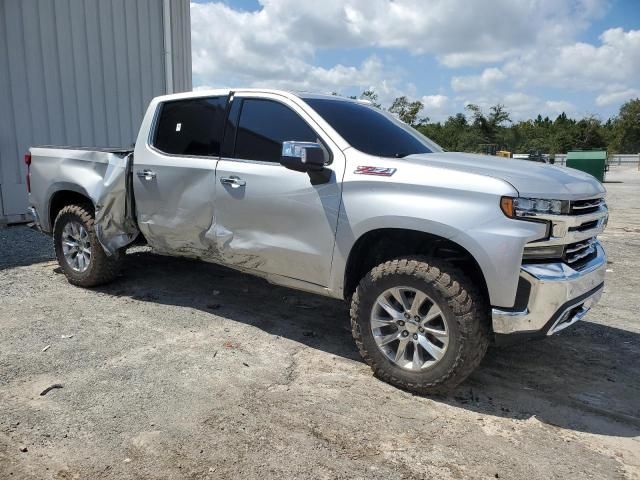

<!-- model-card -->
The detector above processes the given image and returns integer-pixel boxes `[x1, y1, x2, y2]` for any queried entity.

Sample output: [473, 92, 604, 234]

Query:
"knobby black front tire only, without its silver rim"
[351, 256, 489, 394]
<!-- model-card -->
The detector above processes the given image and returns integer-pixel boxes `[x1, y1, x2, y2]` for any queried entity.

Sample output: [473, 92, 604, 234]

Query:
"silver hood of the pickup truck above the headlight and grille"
[402, 152, 606, 200]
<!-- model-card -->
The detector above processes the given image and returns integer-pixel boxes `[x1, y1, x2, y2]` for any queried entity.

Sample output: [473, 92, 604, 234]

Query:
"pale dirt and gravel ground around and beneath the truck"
[0, 166, 640, 479]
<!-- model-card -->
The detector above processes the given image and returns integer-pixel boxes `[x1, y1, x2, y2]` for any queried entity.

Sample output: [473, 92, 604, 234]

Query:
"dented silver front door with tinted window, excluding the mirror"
[215, 93, 344, 286]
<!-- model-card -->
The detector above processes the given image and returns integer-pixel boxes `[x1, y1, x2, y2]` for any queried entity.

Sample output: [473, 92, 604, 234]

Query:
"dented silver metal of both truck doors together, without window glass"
[133, 93, 344, 288]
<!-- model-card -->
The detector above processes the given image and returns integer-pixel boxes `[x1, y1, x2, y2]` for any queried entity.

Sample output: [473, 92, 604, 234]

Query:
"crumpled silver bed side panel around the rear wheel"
[30, 147, 139, 255]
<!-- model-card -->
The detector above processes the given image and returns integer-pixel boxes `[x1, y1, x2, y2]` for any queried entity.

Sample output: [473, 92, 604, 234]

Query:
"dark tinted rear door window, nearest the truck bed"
[153, 97, 227, 157]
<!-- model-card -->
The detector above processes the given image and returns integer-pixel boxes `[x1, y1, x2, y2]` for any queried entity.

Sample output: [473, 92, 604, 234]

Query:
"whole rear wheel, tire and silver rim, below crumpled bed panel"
[53, 205, 123, 287]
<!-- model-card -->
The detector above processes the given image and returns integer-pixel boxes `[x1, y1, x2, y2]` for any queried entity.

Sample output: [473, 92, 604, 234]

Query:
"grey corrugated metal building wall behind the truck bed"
[0, 0, 191, 222]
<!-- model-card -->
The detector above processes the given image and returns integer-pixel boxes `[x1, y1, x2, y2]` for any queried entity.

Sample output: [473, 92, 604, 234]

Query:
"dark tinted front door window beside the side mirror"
[234, 99, 318, 162]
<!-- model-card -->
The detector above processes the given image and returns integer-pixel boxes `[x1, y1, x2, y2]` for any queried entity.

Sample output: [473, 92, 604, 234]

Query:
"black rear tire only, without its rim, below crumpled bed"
[53, 205, 124, 288]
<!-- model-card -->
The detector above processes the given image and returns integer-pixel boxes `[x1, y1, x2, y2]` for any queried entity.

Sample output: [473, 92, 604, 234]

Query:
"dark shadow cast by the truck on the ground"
[99, 251, 640, 437]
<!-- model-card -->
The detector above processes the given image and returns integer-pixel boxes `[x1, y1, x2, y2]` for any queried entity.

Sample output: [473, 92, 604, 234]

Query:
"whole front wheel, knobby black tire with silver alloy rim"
[351, 257, 489, 394]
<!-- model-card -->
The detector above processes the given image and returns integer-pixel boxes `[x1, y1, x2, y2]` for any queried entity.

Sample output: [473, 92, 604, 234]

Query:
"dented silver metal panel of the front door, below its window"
[215, 158, 344, 286]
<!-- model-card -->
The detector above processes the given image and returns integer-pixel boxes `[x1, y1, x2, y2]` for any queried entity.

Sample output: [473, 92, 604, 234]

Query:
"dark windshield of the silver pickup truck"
[303, 97, 442, 158]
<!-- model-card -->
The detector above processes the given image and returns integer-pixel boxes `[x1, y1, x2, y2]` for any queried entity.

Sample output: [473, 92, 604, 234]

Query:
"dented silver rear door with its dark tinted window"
[133, 96, 227, 257]
